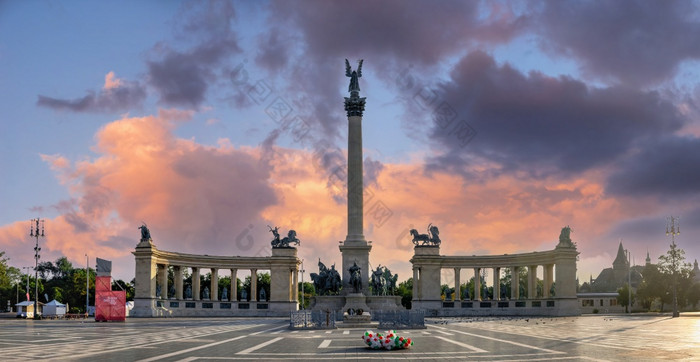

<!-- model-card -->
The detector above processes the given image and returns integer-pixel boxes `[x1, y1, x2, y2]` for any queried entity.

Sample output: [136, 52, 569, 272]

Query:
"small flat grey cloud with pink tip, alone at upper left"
[36, 72, 146, 112]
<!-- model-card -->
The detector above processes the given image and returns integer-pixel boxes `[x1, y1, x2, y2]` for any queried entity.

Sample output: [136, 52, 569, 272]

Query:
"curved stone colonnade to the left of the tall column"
[130, 240, 301, 317]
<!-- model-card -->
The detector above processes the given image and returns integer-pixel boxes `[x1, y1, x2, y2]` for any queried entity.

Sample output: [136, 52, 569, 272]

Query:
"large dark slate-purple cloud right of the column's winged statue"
[423, 52, 684, 175]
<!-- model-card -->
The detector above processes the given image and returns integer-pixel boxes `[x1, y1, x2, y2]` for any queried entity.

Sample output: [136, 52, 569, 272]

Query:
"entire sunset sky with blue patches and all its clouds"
[0, 0, 700, 288]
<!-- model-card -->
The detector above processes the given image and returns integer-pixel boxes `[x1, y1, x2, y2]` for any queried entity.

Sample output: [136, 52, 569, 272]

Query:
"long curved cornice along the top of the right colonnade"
[411, 247, 579, 268]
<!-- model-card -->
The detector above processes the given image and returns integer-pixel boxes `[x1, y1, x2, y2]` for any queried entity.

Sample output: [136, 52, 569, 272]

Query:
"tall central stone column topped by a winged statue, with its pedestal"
[340, 59, 372, 295]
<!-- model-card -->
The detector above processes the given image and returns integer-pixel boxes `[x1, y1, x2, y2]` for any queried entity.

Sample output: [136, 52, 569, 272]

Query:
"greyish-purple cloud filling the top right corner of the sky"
[534, 1, 700, 85]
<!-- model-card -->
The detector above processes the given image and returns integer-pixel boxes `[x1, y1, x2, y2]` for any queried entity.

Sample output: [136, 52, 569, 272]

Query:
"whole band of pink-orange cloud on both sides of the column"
[0, 111, 680, 280]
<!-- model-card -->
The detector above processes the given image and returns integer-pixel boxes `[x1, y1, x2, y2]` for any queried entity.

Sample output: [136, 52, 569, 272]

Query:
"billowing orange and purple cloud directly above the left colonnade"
[0, 111, 277, 273]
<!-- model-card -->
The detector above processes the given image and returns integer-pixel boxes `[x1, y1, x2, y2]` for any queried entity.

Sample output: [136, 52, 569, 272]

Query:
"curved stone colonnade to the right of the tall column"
[411, 239, 581, 316]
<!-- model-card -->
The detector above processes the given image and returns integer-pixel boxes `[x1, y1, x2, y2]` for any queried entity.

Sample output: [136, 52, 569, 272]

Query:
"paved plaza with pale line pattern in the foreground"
[0, 315, 700, 361]
